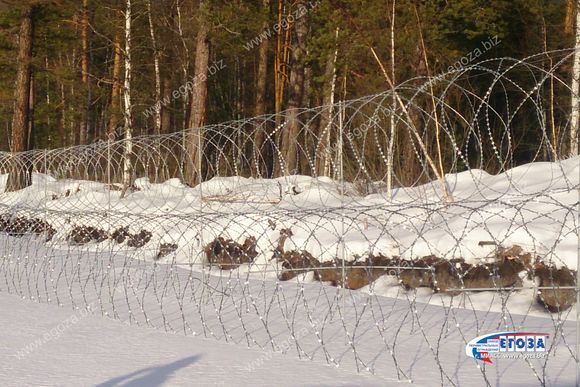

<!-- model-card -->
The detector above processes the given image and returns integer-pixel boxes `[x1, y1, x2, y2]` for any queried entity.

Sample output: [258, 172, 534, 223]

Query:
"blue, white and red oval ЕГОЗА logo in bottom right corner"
[465, 332, 549, 364]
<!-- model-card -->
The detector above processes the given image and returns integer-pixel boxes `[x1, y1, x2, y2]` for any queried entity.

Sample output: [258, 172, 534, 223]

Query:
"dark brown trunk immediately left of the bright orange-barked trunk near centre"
[252, 0, 270, 177]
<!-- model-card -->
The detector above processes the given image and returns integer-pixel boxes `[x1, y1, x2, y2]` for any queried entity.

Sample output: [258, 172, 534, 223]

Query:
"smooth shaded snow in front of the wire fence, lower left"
[0, 293, 385, 387]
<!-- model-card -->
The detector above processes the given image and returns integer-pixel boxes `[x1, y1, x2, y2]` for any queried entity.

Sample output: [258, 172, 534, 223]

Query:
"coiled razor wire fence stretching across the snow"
[0, 50, 580, 385]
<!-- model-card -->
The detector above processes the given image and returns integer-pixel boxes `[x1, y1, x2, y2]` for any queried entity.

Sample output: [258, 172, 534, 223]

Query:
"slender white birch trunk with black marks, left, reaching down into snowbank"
[121, 0, 133, 197]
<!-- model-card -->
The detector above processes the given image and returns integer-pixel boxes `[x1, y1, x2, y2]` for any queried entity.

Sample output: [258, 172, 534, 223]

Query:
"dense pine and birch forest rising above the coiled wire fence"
[0, 0, 577, 190]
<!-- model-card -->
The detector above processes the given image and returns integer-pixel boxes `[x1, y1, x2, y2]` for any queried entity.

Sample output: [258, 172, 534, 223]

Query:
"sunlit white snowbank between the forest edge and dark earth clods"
[0, 156, 580, 315]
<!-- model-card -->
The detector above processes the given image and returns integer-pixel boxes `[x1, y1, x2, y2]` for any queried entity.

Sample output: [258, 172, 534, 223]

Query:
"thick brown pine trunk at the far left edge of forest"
[6, 5, 34, 192]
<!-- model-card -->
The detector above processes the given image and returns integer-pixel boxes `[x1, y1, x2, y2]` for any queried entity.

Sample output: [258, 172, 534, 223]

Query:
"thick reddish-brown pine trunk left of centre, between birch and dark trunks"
[184, 0, 209, 186]
